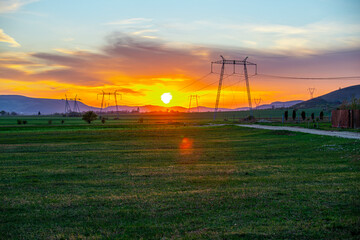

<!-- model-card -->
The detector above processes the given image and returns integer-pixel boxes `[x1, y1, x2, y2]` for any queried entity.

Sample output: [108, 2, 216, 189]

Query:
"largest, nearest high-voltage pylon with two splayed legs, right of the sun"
[211, 55, 257, 120]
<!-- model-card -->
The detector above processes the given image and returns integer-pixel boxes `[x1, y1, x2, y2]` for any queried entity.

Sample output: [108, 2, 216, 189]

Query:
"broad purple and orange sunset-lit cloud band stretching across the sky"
[0, 32, 360, 108]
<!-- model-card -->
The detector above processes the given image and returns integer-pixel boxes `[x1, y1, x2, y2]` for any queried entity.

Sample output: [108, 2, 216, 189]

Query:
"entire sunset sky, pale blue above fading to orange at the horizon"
[0, 0, 360, 108]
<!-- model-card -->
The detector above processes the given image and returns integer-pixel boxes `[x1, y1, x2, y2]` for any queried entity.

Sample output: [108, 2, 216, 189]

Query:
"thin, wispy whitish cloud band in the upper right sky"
[157, 20, 360, 55]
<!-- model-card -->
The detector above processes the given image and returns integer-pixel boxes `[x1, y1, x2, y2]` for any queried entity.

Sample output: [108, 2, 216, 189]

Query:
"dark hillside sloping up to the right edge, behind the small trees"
[293, 85, 360, 108]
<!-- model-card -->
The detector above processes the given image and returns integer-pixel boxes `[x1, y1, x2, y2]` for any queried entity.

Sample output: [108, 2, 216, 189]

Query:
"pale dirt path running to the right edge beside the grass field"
[236, 124, 360, 139]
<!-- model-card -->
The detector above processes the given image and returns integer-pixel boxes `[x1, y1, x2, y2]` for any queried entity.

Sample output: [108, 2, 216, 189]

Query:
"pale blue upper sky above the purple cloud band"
[0, 0, 360, 51]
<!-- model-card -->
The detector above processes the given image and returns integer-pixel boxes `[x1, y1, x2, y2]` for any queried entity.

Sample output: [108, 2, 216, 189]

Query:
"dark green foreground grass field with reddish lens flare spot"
[0, 125, 360, 239]
